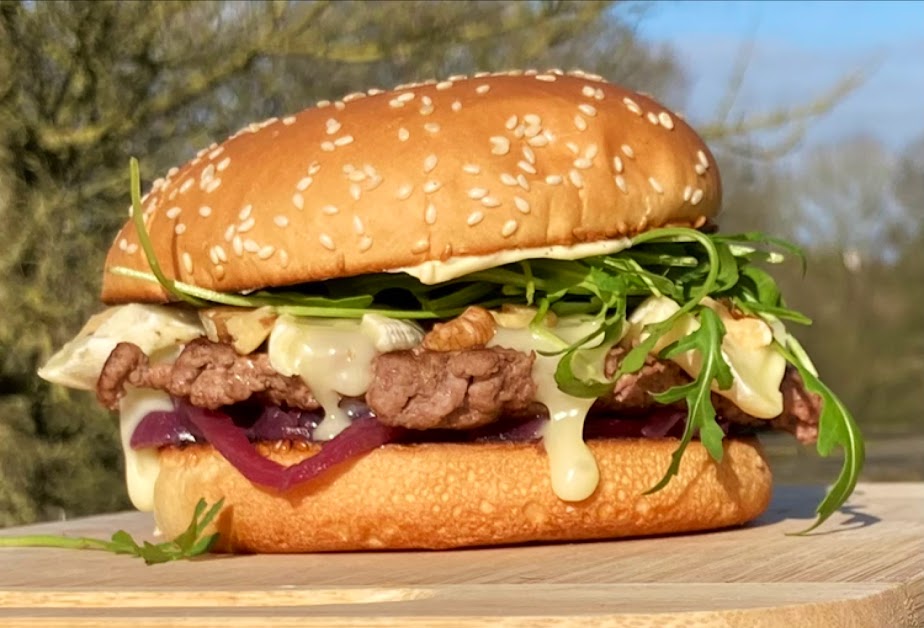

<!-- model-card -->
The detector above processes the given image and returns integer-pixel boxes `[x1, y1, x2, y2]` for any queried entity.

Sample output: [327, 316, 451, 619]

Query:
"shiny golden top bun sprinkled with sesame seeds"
[102, 71, 721, 303]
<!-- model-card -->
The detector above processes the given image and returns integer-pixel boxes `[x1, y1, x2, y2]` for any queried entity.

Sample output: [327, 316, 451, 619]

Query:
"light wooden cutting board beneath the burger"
[0, 483, 924, 628]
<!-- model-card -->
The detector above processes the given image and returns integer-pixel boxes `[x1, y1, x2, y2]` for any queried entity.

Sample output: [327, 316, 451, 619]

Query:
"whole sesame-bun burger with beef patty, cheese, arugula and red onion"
[34, 70, 863, 552]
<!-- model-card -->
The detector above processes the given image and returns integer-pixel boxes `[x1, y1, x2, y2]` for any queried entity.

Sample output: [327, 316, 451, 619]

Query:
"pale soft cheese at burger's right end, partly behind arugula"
[626, 297, 786, 419]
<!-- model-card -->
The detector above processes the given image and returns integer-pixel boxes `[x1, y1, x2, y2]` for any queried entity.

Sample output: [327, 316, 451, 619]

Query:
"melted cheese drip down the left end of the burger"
[119, 388, 173, 512]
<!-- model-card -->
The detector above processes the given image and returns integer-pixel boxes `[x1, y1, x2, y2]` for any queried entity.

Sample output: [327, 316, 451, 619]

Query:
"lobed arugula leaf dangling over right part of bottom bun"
[645, 307, 733, 495]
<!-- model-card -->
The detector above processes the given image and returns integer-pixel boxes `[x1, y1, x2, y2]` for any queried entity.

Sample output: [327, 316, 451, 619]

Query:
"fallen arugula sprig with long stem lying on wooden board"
[0, 499, 224, 565]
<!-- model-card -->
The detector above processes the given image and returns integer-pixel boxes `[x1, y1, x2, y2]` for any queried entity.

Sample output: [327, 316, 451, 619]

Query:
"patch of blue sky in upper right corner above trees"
[639, 0, 924, 150]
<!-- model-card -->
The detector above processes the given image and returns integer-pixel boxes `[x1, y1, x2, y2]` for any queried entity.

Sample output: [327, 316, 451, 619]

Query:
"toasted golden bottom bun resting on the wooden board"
[155, 439, 771, 552]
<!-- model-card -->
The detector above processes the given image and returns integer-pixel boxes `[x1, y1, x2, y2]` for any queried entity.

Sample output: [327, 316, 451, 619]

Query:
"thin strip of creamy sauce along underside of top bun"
[391, 238, 631, 284]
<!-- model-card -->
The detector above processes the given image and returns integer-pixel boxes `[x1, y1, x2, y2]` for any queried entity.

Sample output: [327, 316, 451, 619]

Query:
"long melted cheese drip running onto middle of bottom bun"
[488, 319, 600, 501]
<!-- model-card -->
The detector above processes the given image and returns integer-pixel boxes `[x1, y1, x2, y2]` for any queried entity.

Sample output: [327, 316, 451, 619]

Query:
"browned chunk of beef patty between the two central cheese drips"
[366, 348, 536, 430]
